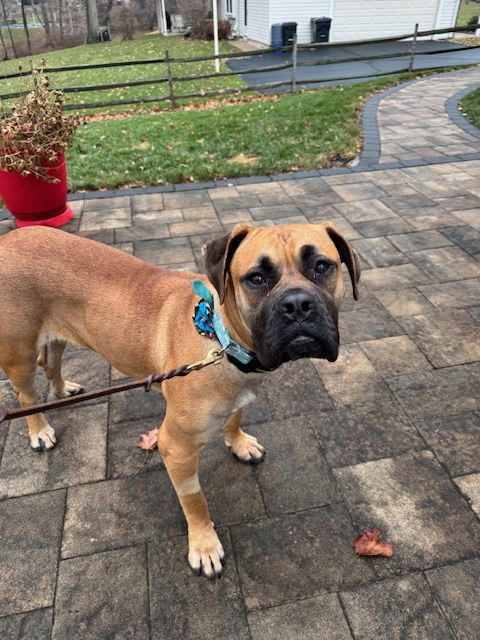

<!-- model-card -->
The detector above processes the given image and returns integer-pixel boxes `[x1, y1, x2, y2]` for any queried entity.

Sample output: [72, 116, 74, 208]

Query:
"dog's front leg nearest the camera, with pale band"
[158, 414, 225, 578]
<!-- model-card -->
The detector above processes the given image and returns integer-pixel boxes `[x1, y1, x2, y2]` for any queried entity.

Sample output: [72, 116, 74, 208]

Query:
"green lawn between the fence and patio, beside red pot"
[68, 74, 438, 191]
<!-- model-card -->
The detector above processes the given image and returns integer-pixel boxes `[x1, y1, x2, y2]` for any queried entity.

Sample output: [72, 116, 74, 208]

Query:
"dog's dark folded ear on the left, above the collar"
[203, 224, 250, 304]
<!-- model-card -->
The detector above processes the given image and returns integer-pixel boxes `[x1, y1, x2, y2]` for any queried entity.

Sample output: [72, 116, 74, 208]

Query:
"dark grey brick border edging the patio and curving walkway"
[0, 67, 480, 221]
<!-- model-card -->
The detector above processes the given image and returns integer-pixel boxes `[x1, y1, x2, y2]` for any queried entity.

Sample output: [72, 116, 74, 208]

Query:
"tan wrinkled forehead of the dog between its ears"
[230, 224, 341, 280]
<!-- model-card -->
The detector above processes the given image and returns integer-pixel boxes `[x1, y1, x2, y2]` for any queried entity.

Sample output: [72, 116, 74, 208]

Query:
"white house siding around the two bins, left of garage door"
[270, 0, 338, 44]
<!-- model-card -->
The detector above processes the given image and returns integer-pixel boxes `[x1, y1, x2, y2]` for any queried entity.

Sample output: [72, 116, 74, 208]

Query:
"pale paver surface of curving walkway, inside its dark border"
[377, 67, 480, 163]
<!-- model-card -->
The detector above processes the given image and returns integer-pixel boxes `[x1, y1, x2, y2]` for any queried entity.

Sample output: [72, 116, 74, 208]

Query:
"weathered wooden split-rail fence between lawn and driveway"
[0, 24, 480, 110]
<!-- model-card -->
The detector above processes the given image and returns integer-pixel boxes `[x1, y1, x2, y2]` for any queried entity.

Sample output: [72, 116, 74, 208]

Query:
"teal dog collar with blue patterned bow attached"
[192, 280, 257, 368]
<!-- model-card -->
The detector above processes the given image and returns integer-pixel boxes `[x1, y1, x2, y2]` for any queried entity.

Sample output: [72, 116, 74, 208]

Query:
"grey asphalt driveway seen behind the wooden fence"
[227, 40, 480, 91]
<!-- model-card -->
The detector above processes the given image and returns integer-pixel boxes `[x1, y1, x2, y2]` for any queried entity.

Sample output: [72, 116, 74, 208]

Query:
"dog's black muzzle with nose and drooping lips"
[253, 288, 339, 368]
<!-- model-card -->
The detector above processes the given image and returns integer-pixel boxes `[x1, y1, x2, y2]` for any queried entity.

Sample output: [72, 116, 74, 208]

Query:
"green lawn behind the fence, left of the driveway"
[0, 34, 244, 113]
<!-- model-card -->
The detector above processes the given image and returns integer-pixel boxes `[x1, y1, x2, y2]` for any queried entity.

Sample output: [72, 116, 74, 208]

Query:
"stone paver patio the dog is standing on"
[0, 70, 480, 640]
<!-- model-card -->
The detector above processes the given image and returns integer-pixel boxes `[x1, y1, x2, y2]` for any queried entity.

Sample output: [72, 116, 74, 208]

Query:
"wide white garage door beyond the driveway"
[330, 0, 440, 42]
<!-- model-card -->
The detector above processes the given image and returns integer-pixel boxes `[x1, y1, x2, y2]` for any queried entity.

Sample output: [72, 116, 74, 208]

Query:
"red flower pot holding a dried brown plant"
[0, 154, 74, 227]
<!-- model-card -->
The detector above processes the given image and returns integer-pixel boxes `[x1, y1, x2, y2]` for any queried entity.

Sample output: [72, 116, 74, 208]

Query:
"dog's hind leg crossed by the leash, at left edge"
[3, 351, 57, 451]
